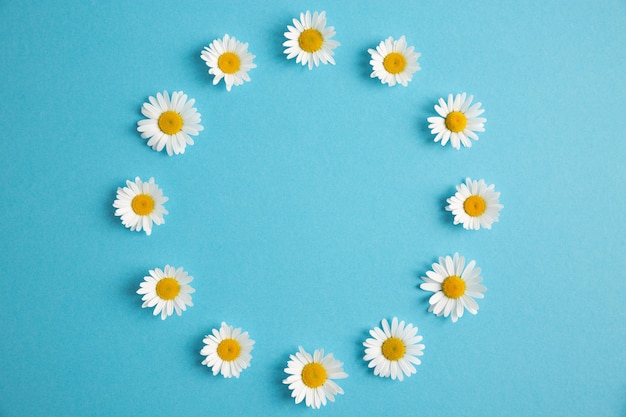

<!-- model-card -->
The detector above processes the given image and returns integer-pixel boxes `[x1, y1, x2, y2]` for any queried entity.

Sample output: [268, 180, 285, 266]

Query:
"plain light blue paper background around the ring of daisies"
[0, 0, 626, 417]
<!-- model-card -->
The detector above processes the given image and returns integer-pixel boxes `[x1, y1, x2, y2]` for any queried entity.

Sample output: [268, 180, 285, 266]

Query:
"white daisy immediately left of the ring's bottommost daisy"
[200, 322, 254, 378]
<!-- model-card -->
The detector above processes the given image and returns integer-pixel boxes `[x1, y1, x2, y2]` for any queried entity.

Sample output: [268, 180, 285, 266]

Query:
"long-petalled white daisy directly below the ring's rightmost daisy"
[420, 253, 487, 323]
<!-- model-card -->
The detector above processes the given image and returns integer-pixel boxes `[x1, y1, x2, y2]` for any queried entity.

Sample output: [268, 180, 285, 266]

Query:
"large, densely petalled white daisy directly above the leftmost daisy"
[137, 91, 204, 156]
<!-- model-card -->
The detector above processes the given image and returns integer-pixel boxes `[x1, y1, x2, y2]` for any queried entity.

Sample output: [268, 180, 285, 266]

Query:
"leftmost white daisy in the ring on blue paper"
[113, 177, 168, 236]
